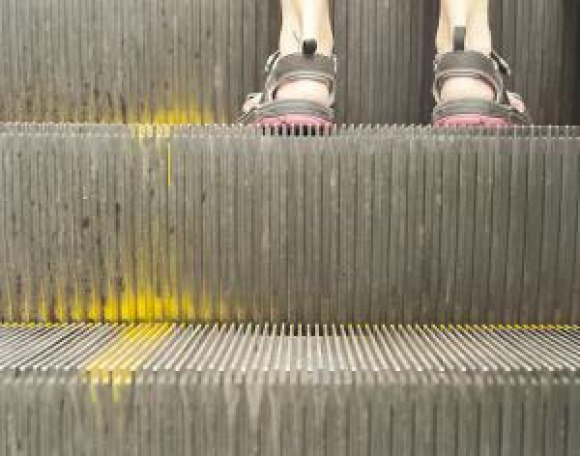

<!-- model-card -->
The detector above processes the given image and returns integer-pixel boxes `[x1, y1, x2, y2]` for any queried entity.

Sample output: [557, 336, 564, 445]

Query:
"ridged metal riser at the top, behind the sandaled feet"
[0, 0, 580, 124]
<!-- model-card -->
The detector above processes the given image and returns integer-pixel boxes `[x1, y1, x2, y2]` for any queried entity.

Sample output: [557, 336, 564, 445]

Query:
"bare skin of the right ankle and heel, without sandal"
[437, 0, 494, 101]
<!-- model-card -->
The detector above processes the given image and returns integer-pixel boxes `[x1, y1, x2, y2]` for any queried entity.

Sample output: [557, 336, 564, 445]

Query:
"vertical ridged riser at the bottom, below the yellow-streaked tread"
[0, 375, 580, 456]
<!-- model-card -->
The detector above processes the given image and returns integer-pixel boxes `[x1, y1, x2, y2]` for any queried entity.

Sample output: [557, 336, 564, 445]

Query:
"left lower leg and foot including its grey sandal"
[240, 0, 336, 127]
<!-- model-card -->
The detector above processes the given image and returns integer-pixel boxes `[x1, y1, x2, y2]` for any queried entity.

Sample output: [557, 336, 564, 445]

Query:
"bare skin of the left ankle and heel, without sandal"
[277, 0, 334, 105]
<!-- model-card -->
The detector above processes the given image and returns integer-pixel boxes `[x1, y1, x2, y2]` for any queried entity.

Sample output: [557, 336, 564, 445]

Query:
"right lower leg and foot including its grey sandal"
[433, 0, 530, 126]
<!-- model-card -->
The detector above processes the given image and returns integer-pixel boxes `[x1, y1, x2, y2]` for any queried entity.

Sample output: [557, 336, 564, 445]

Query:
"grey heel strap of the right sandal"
[433, 51, 509, 103]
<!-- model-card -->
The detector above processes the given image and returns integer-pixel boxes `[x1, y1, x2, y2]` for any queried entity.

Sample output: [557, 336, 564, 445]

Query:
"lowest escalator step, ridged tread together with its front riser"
[0, 324, 580, 456]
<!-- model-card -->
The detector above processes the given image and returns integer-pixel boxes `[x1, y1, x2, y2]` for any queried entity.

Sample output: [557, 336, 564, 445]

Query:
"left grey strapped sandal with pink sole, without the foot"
[239, 51, 336, 127]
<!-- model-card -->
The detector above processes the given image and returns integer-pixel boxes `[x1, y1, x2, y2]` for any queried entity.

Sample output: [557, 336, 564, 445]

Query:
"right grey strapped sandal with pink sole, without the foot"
[433, 27, 531, 127]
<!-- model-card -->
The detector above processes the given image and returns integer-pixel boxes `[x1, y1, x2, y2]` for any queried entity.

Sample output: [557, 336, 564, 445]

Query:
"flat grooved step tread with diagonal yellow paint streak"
[0, 323, 580, 372]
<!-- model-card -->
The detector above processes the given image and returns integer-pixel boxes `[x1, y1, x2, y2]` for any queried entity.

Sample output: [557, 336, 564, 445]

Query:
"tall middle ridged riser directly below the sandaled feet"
[0, 125, 580, 324]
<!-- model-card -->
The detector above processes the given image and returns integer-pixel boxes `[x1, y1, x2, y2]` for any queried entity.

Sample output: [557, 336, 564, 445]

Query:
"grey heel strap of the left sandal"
[262, 53, 337, 103]
